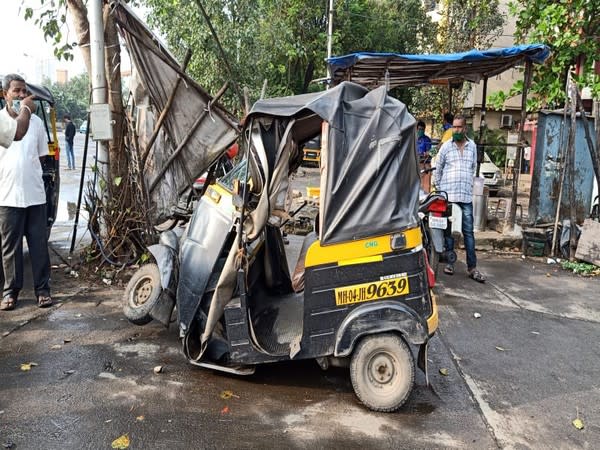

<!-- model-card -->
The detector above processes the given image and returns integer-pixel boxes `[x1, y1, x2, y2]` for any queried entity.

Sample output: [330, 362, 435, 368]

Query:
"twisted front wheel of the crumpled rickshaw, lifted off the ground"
[123, 264, 162, 325]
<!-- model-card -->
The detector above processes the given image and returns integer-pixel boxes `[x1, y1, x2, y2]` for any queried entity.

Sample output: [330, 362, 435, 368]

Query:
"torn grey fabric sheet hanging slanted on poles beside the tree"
[112, 2, 239, 220]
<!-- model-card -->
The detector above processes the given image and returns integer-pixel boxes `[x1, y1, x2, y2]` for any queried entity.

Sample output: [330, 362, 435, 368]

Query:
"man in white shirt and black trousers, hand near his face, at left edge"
[0, 74, 52, 310]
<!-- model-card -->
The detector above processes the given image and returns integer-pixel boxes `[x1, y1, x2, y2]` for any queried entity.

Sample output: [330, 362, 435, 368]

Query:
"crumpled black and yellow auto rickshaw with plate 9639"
[125, 82, 438, 411]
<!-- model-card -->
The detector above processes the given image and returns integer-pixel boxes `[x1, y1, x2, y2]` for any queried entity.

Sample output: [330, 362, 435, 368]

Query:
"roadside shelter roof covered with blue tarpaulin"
[327, 44, 550, 89]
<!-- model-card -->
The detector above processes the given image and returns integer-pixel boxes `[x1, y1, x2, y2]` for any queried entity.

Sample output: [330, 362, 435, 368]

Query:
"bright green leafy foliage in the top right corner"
[492, 0, 600, 111]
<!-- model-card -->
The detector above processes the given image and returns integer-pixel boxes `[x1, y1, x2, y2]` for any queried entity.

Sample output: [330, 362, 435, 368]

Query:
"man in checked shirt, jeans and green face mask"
[434, 115, 485, 283]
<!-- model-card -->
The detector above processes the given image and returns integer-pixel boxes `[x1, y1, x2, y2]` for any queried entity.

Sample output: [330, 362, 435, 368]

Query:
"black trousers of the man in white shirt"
[0, 204, 50, 299]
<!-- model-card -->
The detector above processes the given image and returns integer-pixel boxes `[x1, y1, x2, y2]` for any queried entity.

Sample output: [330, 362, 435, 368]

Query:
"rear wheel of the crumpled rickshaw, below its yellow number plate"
[350, 333, 415, 412]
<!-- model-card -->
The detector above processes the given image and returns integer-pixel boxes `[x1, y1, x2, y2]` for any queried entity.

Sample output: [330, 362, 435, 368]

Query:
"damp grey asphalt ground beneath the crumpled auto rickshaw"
[0, 143, 600, 449]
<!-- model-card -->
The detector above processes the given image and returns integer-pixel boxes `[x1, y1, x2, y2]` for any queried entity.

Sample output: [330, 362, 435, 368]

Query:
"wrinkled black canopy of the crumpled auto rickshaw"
[247, 82, 419, 245]
